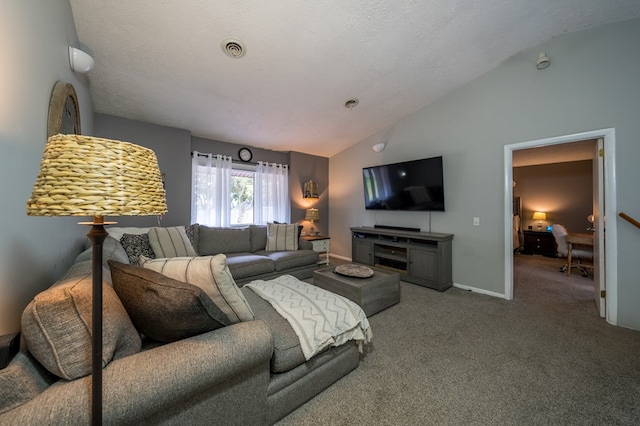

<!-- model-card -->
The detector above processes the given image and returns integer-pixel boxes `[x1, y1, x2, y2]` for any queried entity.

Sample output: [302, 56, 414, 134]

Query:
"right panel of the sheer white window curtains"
[253, 161, 291, 224]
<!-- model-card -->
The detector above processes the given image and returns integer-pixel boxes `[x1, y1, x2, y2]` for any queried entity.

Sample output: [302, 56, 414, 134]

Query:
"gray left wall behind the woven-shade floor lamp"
[0, 0, 93, 335]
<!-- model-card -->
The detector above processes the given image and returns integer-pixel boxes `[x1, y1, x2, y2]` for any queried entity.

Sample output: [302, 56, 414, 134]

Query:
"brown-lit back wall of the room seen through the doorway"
[513, 160, 593, 232]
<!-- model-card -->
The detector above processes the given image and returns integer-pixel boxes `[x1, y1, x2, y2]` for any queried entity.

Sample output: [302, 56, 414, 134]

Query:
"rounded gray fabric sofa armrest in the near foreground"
[0, 321, 273, 425]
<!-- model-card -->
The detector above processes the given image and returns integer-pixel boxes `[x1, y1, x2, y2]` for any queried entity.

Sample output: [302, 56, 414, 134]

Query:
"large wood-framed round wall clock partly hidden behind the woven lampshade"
[47, 81, 80, 138]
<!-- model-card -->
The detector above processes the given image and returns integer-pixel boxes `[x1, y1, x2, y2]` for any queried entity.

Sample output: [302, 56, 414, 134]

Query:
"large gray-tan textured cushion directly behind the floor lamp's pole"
[22, 261, 141, 380]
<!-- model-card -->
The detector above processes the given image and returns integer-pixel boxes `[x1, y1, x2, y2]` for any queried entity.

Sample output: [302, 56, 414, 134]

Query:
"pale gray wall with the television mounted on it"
[329, 19, 640, 329]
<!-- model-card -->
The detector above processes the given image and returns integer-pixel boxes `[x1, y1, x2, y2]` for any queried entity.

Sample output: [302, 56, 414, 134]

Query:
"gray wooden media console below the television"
[351, 227, 453, 291]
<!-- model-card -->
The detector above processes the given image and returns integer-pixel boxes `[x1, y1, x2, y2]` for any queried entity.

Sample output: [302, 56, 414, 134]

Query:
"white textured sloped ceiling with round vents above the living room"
[71, 0, 640, 157]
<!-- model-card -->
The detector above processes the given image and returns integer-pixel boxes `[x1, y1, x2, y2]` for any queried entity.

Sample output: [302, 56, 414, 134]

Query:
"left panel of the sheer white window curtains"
[191, 151, 232, 227]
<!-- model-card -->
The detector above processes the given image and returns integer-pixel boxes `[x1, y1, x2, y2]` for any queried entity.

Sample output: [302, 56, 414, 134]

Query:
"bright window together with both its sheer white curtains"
[191, 152, 290, 227]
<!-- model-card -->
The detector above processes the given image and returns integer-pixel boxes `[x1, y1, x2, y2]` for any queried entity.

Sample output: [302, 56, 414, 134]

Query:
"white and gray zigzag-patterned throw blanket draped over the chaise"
[246, 275, 373, 360]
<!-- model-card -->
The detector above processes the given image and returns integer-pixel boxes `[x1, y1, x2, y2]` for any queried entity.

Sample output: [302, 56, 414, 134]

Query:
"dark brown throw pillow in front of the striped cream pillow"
[109, 261, 231, 342]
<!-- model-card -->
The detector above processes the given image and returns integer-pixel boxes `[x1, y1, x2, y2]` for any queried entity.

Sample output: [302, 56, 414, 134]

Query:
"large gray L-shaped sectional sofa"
[0, 227, 361, 425]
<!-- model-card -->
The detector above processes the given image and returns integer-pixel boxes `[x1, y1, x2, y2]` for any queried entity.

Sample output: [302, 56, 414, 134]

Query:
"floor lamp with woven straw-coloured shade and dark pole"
[27, 134, 167, 425]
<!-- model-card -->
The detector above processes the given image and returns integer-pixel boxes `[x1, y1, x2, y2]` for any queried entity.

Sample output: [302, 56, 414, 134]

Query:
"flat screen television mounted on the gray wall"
[362, 157, 444, 211]
